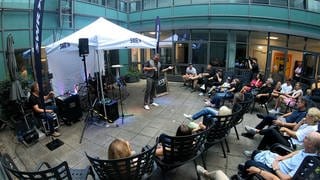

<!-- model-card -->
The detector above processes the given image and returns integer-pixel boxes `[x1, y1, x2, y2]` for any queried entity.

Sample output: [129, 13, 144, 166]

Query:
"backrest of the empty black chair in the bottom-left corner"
[3, 158, 72, 180]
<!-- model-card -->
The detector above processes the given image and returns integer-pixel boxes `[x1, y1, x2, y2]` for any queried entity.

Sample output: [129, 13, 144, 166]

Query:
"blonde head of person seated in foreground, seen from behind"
[108, 138, 135, 160]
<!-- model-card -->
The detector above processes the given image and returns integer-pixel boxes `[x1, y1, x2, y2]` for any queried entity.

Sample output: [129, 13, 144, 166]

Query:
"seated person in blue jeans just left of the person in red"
[205, 78, 241, 108]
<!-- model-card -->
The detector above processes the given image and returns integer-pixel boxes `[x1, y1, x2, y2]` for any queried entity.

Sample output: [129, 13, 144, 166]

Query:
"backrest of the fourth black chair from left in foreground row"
[206, 106, 242, 148]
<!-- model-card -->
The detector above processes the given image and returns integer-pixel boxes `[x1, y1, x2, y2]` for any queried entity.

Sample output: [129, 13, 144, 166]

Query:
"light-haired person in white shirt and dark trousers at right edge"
[248, 107, 320, 150]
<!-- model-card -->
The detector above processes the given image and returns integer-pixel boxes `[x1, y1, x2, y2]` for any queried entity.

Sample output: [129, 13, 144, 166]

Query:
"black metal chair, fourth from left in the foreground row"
[204, 104, 242, 164]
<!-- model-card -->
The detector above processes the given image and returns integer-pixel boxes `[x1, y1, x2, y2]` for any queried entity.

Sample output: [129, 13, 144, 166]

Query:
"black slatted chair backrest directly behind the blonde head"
[86, 143, 157, 180]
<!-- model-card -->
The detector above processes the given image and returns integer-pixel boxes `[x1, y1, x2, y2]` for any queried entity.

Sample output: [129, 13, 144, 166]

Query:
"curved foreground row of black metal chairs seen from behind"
[2, 100, 247, 179]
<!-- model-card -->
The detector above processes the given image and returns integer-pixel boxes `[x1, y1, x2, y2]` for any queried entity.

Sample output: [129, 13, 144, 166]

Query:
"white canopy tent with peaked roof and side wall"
[46, 17, 156, 94]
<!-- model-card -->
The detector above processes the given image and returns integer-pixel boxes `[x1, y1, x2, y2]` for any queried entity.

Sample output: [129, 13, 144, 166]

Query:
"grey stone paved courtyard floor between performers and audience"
[0, 80, 263, 180]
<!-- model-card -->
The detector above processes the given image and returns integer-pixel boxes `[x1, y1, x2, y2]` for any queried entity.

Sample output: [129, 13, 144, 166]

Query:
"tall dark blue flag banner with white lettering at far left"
[33, 0, 45, 107]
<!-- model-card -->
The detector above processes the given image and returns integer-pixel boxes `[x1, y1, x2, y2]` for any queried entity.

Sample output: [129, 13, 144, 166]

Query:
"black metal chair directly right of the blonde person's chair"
[155, 129, 209, 179]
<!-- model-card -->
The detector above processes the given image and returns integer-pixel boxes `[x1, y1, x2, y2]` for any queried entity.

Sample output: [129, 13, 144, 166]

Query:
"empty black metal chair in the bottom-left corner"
[1, 154, 95, 180]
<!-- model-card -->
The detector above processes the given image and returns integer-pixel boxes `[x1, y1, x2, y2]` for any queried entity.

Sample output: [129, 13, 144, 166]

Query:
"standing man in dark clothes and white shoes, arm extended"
[143, 54, 173, 110]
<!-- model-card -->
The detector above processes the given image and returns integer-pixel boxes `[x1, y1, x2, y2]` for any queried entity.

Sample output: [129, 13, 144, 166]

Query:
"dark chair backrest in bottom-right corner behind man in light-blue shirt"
[292, 156, 320, 180]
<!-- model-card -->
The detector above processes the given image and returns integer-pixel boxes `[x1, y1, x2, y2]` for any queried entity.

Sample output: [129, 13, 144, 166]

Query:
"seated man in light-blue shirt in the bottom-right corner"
[244, 132, 320, 180]
